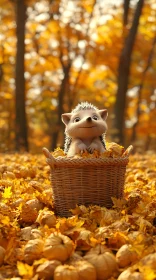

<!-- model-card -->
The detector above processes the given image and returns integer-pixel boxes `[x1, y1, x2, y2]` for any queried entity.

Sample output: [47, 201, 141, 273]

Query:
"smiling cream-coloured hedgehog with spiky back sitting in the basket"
[61, 102, 108, 157]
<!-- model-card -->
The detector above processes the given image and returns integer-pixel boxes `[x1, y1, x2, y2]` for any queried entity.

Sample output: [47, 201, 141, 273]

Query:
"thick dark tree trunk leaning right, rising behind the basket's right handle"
[112, 0, 144, 144]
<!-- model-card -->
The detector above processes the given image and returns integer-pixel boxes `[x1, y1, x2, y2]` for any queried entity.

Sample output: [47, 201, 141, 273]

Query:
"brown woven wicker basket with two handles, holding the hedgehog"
[43, 146, 132, 217]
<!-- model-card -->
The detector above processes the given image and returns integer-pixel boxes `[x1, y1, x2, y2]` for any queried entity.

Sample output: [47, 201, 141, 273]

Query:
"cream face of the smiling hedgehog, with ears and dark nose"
[62, 109, 107, 139]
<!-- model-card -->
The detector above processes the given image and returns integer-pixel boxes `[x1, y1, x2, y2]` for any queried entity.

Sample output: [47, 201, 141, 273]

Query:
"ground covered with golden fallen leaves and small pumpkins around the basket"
[0, 154, 156, 280]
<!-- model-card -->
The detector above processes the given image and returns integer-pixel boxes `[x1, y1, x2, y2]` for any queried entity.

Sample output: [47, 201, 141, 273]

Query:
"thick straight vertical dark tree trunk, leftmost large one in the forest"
[15, 0, 28, 151]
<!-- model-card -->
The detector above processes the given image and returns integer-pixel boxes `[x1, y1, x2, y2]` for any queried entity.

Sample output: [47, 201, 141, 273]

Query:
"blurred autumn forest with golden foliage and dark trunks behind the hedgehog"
[0, 0, 156, 153]
